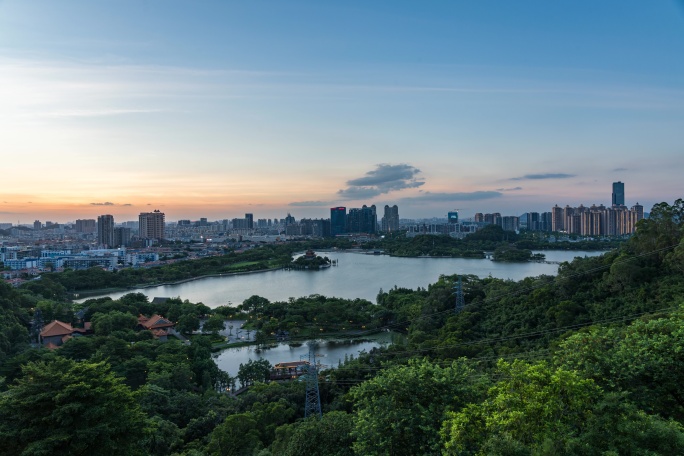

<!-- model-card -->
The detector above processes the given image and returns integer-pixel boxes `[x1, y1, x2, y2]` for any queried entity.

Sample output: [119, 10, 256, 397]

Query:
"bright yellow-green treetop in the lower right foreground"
[442, 360, 601, 454]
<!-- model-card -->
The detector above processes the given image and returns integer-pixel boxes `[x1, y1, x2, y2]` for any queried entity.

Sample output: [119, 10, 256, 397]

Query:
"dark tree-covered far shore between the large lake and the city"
[17, 225, 623, 300]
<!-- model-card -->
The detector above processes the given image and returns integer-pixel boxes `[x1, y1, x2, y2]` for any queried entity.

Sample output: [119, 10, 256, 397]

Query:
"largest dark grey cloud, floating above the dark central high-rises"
[337, 163, 425, 200]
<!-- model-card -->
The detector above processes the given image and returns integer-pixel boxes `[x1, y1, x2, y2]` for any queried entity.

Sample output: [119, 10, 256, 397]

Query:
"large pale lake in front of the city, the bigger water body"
[84, 250, 604, 307]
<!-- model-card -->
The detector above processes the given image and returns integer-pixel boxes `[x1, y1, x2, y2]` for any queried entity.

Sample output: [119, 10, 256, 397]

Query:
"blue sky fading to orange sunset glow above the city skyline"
[0, 0, 684, 224]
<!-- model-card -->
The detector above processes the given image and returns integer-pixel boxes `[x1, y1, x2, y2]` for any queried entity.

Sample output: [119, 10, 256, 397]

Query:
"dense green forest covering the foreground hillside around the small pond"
[0, 199, 684, 456]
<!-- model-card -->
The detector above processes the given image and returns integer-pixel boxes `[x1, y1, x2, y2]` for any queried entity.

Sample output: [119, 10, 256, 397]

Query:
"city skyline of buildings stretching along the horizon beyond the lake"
[0, 182, 644, 281]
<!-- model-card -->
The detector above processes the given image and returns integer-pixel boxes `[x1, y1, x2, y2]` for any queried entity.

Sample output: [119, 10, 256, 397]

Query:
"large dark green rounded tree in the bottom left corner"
[0, 359, 145, 455]
